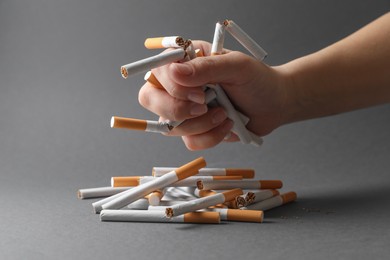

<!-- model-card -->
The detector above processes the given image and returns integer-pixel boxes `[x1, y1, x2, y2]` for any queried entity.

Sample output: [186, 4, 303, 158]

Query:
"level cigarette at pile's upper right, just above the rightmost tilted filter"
[197, 180, 283, 190]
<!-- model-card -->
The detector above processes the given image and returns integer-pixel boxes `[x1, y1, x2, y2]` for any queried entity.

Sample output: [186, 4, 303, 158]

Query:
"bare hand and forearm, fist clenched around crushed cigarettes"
[139, 13, 390, 150]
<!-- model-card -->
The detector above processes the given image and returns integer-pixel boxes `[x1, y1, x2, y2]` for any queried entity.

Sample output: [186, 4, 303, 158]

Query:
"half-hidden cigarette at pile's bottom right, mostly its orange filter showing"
[207, 208, 264, 223]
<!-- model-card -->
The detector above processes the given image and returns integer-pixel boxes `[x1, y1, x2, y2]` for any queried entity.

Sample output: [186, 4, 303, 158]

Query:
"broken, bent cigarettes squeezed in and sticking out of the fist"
[111, 20, 267, 146]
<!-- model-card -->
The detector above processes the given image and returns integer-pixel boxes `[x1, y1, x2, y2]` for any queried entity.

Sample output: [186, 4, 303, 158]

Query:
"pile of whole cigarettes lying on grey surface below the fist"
[78, 157, 297, 224]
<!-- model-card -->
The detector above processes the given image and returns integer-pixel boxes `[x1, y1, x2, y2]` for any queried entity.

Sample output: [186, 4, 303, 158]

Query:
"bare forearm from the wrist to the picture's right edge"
[278, 10, 390, 123]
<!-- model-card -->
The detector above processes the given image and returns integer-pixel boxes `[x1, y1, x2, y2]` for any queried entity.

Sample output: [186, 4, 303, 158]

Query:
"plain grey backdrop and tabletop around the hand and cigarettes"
[0, 0, 390, 259]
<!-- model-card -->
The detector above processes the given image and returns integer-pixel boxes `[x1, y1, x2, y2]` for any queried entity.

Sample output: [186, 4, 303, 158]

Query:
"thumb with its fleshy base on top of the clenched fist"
[169, 51, 261, 87]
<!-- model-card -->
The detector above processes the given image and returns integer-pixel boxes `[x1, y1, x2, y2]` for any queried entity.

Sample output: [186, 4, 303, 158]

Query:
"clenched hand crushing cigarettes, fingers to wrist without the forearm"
[139, 41, 287, 150]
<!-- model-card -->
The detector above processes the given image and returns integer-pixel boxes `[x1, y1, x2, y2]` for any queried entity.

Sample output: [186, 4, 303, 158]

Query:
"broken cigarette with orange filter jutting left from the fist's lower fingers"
[110, 116, 171, 133]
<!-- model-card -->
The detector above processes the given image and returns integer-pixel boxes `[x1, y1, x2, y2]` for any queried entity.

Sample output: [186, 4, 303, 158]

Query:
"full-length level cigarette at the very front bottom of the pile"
[100, 210, 220, 224]
